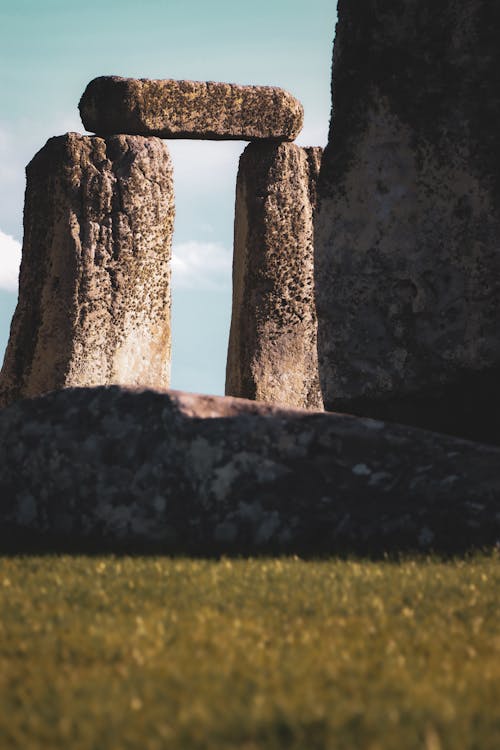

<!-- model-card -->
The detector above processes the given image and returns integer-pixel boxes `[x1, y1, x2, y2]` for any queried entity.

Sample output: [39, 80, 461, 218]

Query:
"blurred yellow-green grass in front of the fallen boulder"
[0, 555, 500, 750]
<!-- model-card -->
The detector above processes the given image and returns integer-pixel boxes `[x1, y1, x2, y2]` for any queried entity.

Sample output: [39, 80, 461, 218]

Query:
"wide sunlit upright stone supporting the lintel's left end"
[0, 133, 174, 405]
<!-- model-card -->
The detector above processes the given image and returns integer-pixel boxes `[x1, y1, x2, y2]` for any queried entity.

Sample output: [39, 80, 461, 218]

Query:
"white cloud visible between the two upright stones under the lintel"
[172, 240, 232, 290]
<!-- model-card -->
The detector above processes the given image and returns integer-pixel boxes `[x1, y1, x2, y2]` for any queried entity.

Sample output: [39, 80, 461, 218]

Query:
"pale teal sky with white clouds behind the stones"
[0, 0, 336, 394]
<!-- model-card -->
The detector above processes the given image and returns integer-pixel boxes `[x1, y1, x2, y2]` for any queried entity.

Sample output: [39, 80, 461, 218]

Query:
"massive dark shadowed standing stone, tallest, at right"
[316, 0, 500, 441]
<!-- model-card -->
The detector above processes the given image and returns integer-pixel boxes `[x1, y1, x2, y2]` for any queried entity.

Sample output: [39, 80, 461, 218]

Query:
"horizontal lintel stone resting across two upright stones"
[80, 76, 304, 141]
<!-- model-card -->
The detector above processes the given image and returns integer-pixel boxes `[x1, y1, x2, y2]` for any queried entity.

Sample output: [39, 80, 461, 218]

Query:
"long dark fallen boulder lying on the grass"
[0, 386, 500, 555]
